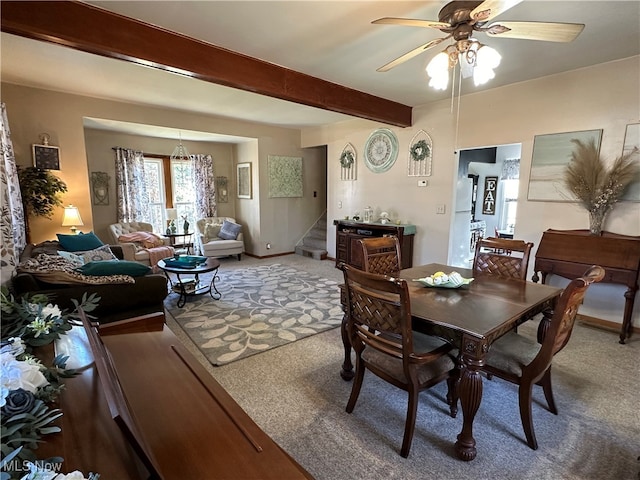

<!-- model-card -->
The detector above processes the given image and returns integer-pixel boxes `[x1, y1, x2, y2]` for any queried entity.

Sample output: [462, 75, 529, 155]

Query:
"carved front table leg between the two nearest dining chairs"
[456, 335, 486, 461]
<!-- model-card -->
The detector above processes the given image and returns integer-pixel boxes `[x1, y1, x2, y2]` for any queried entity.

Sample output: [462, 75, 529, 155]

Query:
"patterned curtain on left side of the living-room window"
[114, 147, 150, 222]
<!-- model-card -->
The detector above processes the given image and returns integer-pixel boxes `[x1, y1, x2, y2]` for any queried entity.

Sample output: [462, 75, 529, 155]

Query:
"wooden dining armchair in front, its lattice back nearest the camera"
[342, 264, 458, 458]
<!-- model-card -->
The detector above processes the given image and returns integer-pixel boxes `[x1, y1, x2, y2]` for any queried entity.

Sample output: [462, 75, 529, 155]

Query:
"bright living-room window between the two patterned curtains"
[144, 156, 196, 233]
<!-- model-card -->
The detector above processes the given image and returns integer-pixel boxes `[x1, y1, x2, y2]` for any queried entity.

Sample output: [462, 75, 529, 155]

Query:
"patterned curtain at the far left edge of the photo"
[0, 103, 27, 283]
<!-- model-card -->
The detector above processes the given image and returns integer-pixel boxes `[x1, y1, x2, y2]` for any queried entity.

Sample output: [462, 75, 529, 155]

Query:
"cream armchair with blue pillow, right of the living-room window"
[196, 217, 244, 260]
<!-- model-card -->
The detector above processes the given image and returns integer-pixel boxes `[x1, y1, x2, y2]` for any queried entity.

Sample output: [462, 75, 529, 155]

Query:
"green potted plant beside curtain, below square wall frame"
[18, 166, 67, 242]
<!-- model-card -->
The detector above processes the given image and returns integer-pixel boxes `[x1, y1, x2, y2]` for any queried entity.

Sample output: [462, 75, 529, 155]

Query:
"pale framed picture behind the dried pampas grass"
[527, 130, 602, 202]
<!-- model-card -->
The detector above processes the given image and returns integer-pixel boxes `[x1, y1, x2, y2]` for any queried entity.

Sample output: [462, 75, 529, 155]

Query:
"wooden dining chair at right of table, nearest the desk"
[482, 265, 604, 450]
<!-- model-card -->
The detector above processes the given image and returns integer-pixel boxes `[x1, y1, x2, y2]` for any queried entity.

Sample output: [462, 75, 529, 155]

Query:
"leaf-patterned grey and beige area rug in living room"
[165, 264, 342, 365]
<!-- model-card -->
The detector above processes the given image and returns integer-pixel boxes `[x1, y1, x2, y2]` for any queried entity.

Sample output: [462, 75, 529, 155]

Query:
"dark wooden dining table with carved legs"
[340, 263, 562, 461]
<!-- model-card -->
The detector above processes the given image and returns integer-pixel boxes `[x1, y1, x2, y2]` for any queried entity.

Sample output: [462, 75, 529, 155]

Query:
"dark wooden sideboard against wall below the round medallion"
[333, 220, 416, 268]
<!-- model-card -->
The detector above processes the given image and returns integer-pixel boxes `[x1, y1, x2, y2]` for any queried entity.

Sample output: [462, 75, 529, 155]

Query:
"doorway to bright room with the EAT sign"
[448, 143, 522, 268]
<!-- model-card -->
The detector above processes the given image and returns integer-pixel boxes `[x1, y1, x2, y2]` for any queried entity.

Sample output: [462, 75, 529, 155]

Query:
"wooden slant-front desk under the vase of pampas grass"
[532, 229, 640, 343]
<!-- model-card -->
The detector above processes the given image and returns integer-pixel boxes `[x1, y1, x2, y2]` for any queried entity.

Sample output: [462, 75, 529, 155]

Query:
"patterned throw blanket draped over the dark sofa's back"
[16, 253, 135, 285]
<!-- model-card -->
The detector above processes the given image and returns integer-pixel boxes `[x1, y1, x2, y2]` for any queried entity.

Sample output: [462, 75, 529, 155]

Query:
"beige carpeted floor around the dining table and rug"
[167, 255, 640, 480]
